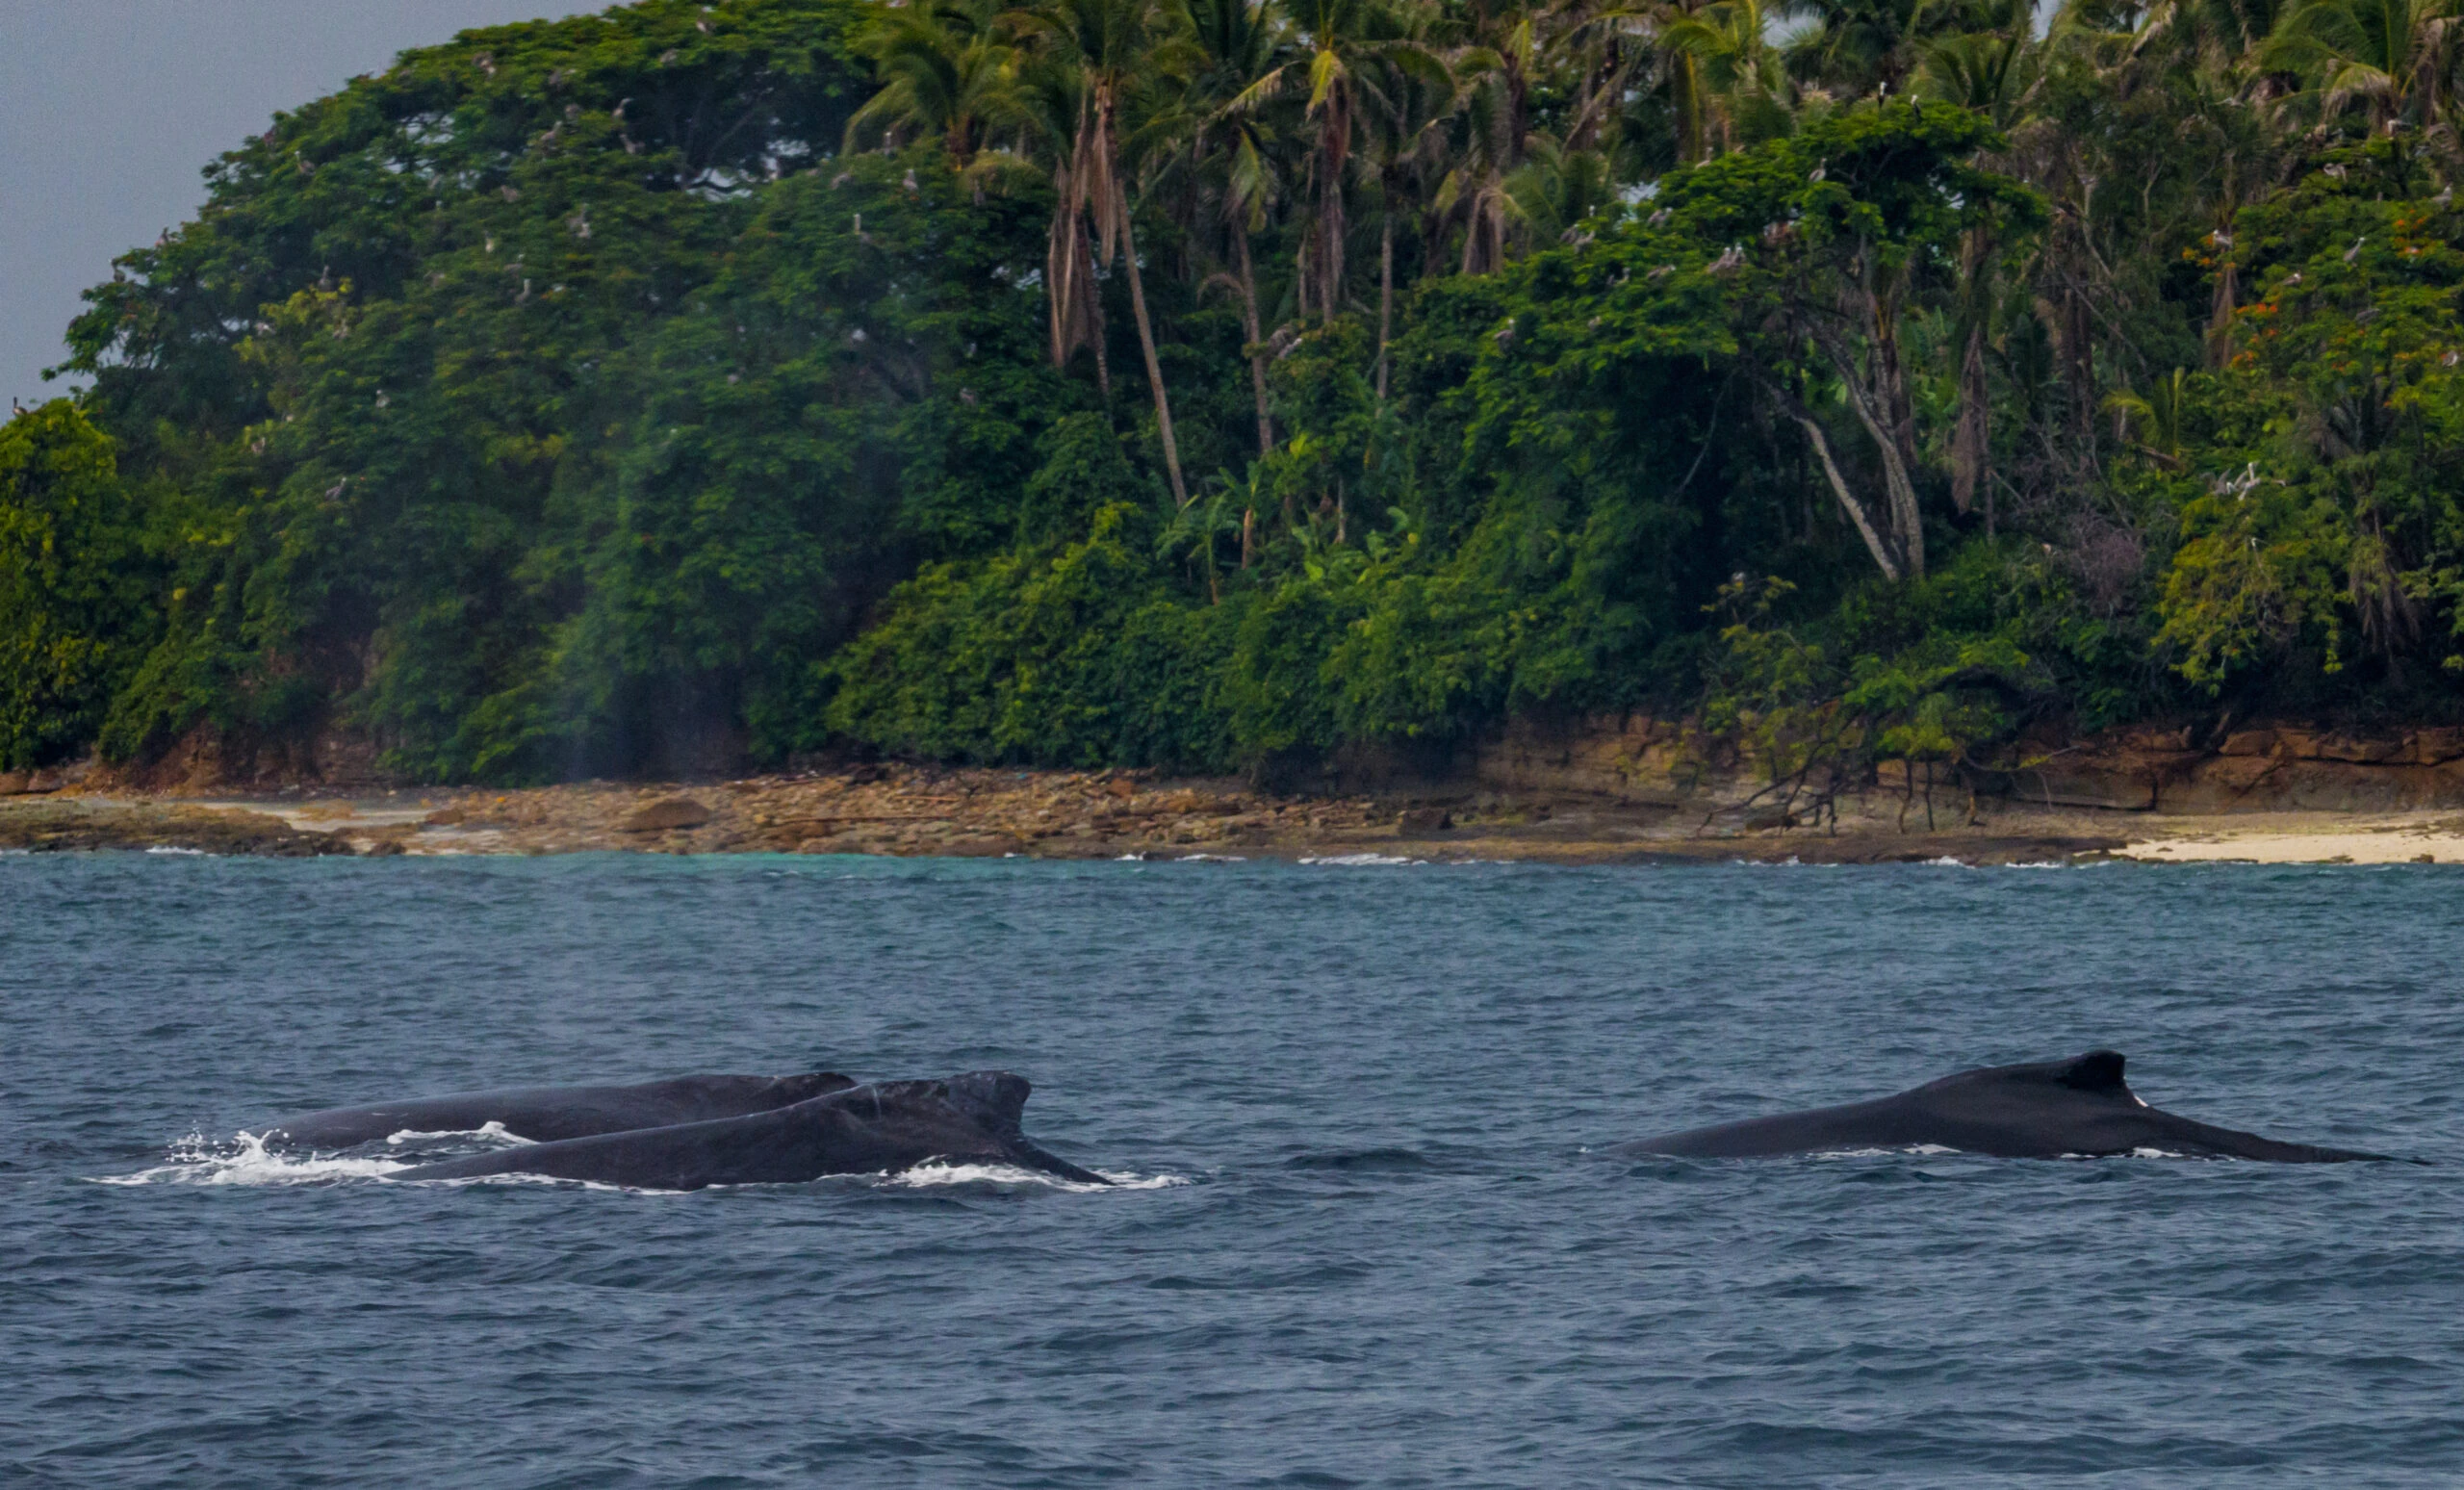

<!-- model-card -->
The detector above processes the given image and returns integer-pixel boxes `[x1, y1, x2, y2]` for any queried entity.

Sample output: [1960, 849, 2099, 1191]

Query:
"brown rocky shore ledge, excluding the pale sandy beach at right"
[0, 766, 2158, 864]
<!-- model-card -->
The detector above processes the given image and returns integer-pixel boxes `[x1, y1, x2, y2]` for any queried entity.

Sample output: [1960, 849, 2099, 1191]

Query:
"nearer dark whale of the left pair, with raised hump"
[387, 1071, 1109, 1190]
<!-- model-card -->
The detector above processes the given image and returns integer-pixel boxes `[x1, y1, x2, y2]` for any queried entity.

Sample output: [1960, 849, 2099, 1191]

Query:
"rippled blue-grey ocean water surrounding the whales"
[0, 855, 2464, 1490]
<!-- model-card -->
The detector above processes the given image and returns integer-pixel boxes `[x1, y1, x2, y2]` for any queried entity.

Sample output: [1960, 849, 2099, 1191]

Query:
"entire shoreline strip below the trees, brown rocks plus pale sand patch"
[14, 736, 2464, 864]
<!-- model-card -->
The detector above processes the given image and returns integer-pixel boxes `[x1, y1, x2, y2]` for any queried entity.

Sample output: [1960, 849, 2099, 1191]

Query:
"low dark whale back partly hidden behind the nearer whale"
[266, 1071, 855, 1147]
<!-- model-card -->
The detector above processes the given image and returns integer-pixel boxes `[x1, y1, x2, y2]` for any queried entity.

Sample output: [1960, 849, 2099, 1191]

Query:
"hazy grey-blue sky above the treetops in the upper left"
[0, 0, 606, 404]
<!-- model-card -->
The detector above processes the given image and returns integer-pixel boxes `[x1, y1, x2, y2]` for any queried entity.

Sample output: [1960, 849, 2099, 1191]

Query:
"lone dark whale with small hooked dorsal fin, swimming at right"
[1609, 1049, 2385, 1165]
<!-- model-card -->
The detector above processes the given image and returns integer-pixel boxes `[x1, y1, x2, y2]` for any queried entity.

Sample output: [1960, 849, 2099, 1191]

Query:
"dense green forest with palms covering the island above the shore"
[14, 0, 2464, 781]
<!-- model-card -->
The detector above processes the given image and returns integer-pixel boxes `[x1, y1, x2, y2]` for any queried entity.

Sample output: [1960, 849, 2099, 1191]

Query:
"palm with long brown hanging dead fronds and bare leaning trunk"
[1011, 0, 1190, 507]
